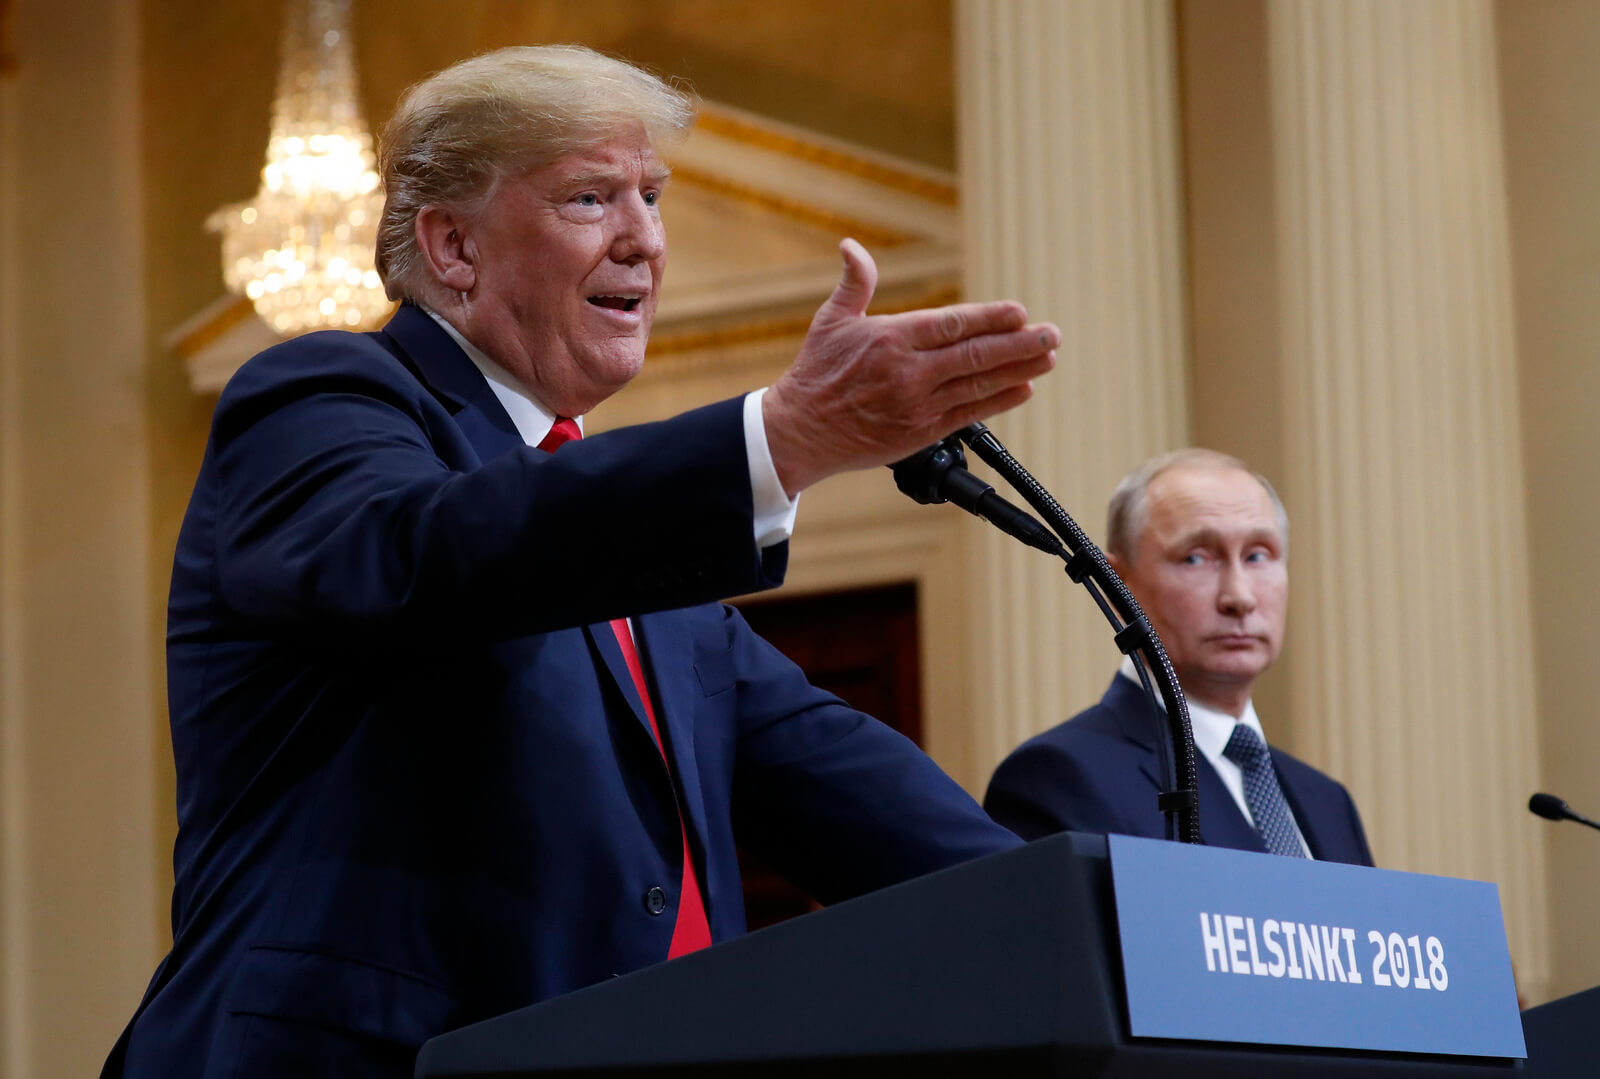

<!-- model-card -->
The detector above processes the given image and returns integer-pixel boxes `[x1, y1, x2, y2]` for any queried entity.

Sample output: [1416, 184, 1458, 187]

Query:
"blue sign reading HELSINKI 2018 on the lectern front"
[1107, 836, 1528, 1057]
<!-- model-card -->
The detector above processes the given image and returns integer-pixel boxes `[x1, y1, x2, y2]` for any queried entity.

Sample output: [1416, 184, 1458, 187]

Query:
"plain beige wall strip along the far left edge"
[0, 0, 166, 1079]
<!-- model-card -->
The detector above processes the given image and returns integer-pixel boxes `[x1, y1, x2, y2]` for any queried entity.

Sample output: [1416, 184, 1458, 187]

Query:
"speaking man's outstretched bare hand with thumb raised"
[762, 240, 1061, 496]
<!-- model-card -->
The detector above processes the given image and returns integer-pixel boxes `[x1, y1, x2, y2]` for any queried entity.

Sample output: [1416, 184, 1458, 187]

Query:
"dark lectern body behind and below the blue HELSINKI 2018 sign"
[416, 834, 1520, 1079]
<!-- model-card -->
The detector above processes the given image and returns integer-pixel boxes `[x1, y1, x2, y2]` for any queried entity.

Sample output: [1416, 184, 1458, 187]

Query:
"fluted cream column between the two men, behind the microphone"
[955, 0, 1187, 788]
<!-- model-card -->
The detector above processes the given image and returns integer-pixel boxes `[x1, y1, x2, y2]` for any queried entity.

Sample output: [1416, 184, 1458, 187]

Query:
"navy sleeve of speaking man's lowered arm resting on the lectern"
[726, 610, 1018, 903]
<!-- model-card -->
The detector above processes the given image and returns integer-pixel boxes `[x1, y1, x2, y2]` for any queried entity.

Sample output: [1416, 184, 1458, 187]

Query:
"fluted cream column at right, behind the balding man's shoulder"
[1267, 0, 1547, 991]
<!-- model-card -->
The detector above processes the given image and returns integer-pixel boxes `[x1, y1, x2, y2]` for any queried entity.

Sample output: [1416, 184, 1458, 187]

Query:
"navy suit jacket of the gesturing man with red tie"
[107, 306, 1016, 1079]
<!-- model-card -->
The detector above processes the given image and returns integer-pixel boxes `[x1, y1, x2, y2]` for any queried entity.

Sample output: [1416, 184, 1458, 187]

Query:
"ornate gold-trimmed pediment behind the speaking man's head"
[166, 102, 960, 392]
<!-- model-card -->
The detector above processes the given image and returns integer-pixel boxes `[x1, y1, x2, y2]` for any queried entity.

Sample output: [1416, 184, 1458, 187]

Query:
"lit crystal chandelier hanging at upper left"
[206, 0, 390, 336]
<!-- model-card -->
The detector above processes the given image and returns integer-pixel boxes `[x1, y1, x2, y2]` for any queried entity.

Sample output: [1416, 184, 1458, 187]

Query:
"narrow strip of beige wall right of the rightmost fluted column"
[1498, 0, 1600, 994]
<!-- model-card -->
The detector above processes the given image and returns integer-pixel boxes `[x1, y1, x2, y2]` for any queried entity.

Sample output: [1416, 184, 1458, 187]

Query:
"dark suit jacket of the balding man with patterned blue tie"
[984, 674, 1373, 866]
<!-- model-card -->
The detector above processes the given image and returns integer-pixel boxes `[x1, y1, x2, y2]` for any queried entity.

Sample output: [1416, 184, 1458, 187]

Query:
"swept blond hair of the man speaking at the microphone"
[378, 45, 696, 299]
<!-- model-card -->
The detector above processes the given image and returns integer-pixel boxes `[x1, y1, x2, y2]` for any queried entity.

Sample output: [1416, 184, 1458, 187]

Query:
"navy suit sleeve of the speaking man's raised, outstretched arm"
[200, 335, 782, 644]
